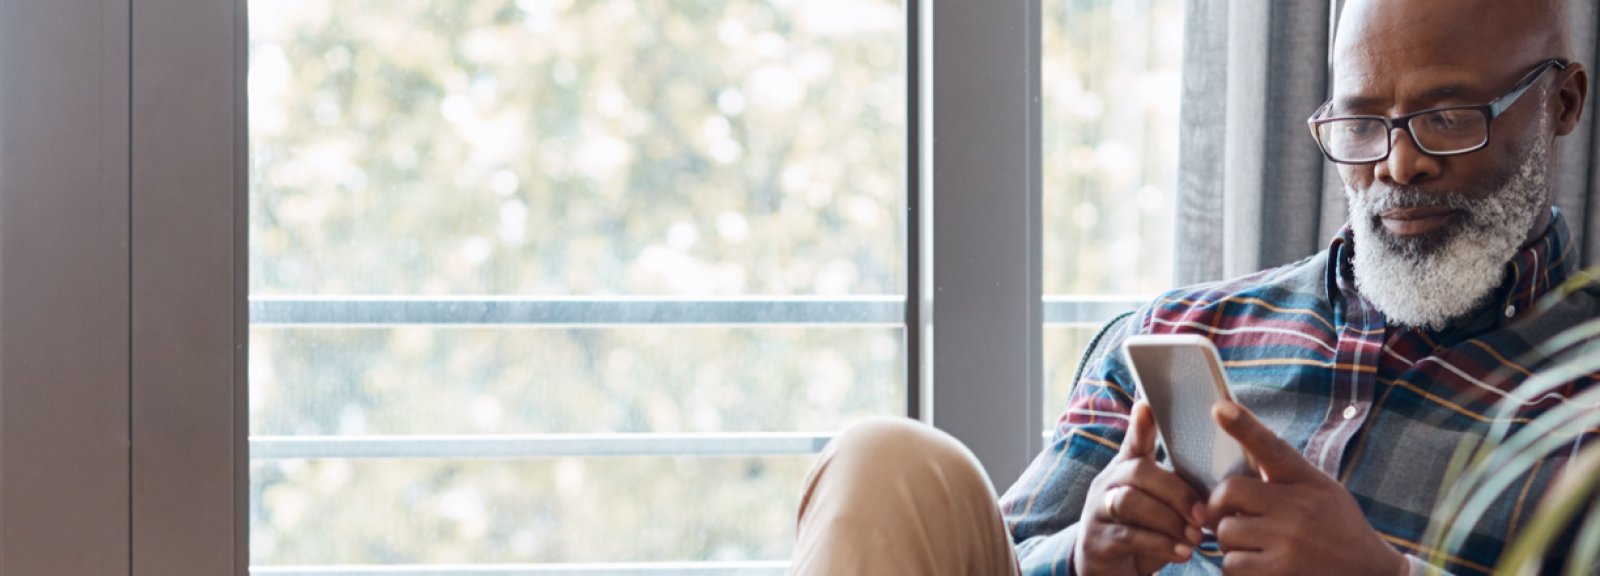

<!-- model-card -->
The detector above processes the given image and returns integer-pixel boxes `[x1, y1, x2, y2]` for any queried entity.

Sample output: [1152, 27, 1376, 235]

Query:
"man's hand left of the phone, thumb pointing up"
[1074, 402, 1203, 576]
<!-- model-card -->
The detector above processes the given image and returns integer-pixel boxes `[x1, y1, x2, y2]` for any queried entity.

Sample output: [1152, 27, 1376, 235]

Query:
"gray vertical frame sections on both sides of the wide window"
[0, 0, 1077, 576]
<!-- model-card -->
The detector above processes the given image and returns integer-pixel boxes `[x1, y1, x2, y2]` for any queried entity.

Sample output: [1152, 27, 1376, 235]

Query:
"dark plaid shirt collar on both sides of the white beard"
[1328, 206, 1573, 332]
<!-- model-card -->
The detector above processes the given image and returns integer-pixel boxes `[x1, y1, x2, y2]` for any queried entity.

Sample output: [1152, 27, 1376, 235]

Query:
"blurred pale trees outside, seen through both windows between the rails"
[250, 0, 1182, 565]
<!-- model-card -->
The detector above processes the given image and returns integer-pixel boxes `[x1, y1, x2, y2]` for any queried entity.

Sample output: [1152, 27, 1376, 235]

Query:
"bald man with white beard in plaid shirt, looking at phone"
[790, 0, 1600, 576]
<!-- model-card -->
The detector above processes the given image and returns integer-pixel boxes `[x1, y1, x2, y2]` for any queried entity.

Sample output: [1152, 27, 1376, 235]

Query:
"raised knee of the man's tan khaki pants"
[789, 418, 1021, 576]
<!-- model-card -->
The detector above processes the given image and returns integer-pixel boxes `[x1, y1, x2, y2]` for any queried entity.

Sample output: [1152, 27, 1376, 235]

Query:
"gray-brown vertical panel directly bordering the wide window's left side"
[131, 0, 248, 574]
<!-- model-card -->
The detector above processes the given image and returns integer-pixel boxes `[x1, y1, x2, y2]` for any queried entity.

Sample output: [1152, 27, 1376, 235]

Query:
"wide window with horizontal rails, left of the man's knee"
[250, 0, 907, 573]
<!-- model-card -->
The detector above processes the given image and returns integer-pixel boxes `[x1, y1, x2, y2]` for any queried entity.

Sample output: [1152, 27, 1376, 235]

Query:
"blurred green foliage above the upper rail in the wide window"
[250, 0, 906, 294]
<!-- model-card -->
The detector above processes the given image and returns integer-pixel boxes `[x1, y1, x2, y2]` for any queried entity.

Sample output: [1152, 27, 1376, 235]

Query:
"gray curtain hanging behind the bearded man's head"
[1173, 0, 1600, 285]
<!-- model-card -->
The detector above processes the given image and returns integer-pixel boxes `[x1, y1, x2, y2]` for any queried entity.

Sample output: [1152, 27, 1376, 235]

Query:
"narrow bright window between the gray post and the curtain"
[1040, 0, 1184, 429]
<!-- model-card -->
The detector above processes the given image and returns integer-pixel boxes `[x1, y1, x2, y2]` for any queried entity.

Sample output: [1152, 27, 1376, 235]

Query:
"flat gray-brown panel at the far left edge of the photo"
[0, 0, 128, 574]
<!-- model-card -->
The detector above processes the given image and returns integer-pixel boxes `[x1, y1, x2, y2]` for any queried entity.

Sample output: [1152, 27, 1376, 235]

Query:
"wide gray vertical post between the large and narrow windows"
[923, 0, 1043, 488]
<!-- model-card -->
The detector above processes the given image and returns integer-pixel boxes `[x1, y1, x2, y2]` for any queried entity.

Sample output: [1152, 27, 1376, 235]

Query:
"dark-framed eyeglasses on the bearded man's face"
[1306, 59, 1566, 163]
